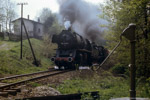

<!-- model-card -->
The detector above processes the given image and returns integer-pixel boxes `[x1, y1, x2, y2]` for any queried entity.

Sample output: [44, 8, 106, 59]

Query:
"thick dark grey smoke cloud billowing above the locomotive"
[58, 0, 104, 41]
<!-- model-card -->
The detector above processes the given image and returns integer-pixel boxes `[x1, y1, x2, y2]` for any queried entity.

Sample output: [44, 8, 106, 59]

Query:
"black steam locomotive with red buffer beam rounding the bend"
[51, 29, 108, 69]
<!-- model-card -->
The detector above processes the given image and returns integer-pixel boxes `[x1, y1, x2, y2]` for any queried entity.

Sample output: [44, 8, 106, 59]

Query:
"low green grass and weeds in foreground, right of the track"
[56, 71, 150, 100]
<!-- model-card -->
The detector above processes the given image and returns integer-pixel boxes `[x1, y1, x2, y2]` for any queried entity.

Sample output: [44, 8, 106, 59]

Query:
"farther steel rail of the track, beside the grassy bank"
[0, 69, 55, 81]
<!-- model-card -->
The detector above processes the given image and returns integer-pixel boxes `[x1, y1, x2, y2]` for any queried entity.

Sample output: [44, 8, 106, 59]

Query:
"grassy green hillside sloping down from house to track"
[0, 39, 55, 76]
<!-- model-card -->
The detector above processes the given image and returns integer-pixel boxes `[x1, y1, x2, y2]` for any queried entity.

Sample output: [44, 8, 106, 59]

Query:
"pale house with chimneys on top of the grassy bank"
[12, 16, 44, 38]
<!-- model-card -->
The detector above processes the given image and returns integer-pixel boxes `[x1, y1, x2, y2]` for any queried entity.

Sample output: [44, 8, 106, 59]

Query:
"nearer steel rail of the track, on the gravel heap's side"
[0, 70, 72, 90]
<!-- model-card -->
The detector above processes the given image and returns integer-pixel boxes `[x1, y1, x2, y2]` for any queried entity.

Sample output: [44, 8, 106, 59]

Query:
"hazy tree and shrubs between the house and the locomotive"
[37, 8, 64, 58]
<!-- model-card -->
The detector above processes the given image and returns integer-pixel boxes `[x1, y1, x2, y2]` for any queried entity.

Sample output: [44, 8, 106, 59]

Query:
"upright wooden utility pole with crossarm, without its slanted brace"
[17, 3, 27, 59]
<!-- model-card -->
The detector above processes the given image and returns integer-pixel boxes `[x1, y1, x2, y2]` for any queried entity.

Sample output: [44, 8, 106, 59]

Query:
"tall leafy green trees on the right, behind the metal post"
[103, 0, 150, 78]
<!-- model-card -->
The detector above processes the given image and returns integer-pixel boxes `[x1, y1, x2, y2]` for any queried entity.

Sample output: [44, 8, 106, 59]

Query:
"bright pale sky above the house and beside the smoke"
[12, 0, 104, 20]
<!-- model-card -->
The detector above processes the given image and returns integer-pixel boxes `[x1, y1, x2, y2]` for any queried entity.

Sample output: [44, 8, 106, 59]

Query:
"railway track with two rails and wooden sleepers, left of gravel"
[0, 69, 71, 97]
